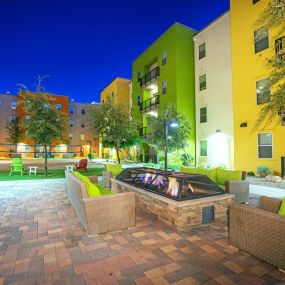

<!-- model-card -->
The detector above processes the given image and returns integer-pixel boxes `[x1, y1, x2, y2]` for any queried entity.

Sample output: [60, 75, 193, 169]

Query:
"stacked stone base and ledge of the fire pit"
[111, 179, 234, 230]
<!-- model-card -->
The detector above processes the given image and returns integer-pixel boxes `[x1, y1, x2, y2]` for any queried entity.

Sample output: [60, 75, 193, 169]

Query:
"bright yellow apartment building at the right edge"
[230, 0, 285, 175]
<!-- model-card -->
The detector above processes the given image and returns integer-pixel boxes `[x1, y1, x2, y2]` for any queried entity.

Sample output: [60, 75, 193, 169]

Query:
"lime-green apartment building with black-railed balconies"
[132, 23, 196, 161]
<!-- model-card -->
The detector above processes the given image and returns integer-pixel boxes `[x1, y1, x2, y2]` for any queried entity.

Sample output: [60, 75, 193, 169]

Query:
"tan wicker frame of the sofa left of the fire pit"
[65, 171, 135, 234]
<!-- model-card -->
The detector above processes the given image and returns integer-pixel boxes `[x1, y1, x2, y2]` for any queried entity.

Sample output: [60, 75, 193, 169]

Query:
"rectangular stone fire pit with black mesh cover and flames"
[111, 167, 234, 230]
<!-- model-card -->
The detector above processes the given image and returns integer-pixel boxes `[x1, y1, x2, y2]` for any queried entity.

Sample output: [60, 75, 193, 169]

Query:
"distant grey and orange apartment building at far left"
[0, 92, 99, 158]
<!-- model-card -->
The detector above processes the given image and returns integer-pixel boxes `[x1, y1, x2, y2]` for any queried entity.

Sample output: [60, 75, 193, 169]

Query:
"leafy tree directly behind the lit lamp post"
[145, 104, 191, 152]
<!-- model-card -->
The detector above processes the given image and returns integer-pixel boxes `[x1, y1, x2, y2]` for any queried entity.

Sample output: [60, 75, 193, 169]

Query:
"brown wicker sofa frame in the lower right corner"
[229, 197, 285, 270]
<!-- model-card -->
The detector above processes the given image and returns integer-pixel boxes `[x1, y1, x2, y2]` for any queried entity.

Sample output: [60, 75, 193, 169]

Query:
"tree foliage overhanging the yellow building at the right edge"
[254, 0, 285, 129]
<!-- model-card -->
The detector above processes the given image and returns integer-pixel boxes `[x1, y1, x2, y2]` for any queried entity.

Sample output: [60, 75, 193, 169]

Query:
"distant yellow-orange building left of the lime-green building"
[99, 77, 132, 159]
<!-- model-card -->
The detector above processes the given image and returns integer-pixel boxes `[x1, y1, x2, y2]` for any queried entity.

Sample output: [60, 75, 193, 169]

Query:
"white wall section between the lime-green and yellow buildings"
[194, 12, 234, 168]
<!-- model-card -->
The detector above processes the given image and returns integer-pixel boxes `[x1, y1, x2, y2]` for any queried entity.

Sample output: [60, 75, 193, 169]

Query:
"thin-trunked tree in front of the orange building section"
[20, 91, 67, 176]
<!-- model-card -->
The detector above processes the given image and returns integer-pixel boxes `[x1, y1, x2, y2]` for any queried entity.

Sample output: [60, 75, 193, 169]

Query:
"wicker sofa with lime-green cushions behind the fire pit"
[180, 166, 249, 203]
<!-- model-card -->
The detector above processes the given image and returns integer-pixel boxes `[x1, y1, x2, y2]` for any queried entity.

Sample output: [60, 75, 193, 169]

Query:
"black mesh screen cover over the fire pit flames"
[116, 168, 225, 201]
